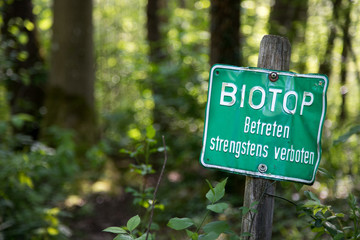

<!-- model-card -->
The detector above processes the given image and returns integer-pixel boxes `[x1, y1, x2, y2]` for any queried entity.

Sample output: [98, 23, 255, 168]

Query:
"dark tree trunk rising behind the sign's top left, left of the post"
[210, 0, 241, 66]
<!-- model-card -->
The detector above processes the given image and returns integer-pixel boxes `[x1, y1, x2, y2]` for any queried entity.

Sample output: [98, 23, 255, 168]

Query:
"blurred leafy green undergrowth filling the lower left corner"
[0, 119, 78, 240]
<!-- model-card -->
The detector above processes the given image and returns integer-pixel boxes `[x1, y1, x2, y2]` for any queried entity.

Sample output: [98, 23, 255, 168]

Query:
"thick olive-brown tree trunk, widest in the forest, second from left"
[45, 0, 97, 150]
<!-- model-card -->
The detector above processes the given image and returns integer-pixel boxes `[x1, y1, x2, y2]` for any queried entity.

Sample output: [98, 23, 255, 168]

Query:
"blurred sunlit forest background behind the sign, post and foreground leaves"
[0, 0, 360, 240]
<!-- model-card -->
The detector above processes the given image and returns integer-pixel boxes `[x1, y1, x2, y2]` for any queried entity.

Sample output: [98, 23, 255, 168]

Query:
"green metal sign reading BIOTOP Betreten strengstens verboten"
[200, 65, 328, 184]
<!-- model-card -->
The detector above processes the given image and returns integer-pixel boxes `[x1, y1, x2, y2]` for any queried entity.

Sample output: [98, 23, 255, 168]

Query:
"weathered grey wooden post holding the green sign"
[242, 35, 291, 240]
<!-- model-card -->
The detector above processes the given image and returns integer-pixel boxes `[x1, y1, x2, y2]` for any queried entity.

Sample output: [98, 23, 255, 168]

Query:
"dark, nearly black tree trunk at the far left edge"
[1, 0, 47, 139]
